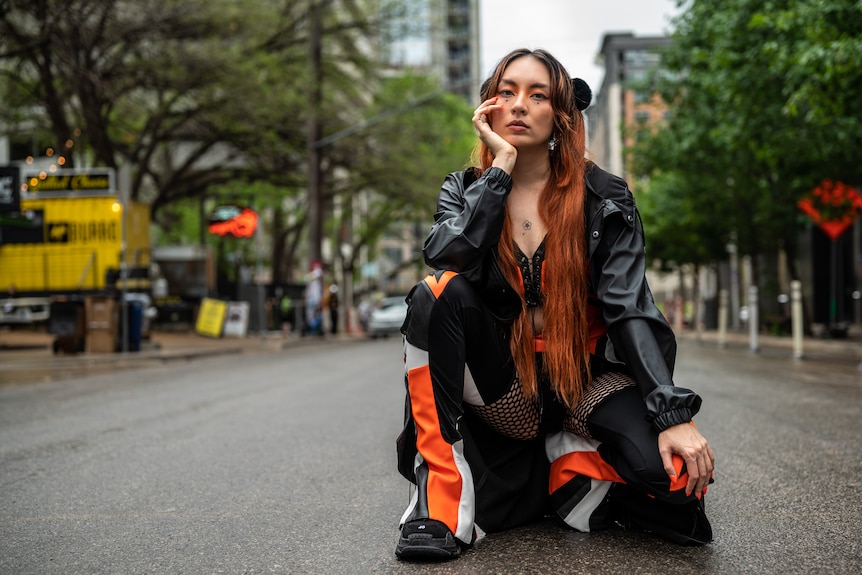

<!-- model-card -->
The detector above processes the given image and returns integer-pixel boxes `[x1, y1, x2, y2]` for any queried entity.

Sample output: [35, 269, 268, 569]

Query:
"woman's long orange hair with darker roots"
[474, 49, 590, 407]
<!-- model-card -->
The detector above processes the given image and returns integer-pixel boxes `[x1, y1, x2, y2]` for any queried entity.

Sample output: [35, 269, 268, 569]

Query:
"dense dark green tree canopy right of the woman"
[633, 0, 862, 276]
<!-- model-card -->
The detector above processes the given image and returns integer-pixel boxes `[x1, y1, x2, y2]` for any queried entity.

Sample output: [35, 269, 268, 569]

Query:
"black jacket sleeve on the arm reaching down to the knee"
[590, 184, 701, 432]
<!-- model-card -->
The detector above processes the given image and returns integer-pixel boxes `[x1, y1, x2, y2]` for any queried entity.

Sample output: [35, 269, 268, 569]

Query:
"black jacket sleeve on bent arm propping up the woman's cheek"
[422, 168, 512, 275]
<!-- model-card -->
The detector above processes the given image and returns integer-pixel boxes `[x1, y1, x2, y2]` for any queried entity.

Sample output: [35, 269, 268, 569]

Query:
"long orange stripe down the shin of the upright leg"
[407, 365, 463, 533]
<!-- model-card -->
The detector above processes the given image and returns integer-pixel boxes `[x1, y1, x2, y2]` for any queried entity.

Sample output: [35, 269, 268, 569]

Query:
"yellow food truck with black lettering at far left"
[0, 170, 150, 324]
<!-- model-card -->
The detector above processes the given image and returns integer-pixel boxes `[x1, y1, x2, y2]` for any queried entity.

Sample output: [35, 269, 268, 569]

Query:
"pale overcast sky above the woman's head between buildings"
[479, 0, 678, 92]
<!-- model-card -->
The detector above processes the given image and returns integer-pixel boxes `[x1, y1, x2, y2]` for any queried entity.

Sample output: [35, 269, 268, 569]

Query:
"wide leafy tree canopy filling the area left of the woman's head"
[0, 0, 469, 288]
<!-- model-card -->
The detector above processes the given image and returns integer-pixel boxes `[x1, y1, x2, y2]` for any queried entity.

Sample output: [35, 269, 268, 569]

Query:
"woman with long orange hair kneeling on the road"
[396, 50, 715, 560]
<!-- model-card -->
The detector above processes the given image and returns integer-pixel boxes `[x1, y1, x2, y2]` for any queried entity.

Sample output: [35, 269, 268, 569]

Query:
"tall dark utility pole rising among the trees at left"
[306, 0, 323, 262]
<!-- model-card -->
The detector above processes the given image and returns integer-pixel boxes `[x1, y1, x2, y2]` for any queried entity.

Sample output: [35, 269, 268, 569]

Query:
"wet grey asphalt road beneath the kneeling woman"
[0, 339, 862, 575]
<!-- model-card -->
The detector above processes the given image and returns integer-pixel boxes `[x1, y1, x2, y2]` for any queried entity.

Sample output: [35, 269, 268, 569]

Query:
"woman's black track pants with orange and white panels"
[398, 272, 705, 544]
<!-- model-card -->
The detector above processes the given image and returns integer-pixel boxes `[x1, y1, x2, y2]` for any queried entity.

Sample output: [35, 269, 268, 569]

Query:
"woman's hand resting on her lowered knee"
[658, 423, 715, 497]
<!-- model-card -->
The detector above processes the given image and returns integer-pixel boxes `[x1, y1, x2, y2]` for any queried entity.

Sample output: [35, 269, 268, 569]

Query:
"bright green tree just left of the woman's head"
[332, 73, 475, 288]
